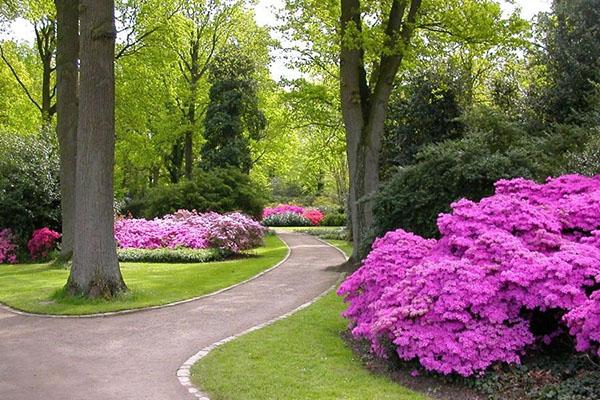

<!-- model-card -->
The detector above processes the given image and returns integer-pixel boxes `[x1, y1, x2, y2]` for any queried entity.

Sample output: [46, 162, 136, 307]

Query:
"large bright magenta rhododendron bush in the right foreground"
[338, 175, 600, 376]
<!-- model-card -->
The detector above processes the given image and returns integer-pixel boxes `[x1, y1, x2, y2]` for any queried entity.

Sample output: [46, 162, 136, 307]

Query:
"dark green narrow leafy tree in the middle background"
[201, 45, 266, 174]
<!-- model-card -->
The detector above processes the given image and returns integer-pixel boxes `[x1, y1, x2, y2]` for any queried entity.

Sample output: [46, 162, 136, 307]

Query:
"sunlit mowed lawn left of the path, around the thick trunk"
[0, 236, 287, 315]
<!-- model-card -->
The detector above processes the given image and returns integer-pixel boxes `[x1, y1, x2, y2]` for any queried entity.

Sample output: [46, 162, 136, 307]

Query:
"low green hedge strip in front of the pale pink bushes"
[117, 248, 226, 264]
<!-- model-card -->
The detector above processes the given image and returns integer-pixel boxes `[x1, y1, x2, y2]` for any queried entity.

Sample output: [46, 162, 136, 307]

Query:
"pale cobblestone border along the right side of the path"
[177, 239, 348, 400]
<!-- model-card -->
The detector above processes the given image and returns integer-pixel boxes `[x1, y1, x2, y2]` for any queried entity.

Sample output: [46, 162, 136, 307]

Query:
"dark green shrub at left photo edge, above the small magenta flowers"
[0, 133, 60, 242]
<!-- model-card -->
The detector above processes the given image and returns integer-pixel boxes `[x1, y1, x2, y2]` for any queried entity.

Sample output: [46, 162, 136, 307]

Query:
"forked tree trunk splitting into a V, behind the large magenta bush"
[340, 0, 421, 262]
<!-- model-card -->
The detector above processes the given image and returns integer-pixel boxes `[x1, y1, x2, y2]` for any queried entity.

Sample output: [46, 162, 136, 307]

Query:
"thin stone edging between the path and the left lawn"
[0, 238, 292, 319]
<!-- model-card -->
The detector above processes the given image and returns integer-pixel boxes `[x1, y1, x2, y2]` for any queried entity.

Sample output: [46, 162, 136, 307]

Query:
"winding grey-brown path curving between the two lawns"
[0, 232, 345, 400]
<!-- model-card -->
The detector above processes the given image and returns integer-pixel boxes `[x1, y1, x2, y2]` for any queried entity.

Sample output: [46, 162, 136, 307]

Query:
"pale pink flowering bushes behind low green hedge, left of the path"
[115, 210, 266, 253]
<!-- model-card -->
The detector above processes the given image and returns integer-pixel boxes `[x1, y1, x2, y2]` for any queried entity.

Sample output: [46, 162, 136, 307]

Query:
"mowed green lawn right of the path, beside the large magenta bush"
[192, 241, 427, 400]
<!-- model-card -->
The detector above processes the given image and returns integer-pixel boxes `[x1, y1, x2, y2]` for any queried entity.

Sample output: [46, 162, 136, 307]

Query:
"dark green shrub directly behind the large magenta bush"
[374, 110, 550, 237]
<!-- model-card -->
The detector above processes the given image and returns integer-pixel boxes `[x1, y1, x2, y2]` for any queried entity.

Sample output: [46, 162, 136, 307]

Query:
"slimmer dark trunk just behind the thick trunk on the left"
[55, 0, 79, 261]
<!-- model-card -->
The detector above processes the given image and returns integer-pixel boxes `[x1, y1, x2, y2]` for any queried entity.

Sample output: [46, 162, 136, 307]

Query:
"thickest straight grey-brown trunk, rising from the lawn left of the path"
[67, 0, 127, 297]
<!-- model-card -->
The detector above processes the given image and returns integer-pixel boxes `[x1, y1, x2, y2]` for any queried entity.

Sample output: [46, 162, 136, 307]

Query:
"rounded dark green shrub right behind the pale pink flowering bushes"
[134, 168, 265, 218]
